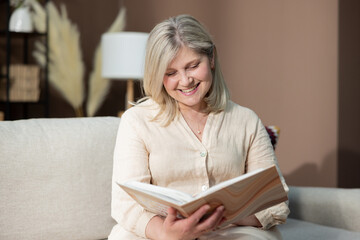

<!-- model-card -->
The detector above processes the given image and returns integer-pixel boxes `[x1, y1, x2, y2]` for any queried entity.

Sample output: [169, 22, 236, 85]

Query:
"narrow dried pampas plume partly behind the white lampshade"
[86, 8, 126, 117]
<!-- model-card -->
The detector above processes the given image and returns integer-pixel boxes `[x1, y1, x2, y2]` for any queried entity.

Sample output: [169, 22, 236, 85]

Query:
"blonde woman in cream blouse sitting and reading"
[109, 15, 289, 240]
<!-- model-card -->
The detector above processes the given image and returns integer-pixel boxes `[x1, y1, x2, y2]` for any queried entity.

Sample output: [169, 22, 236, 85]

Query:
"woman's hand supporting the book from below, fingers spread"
[146, 205, 225, 240]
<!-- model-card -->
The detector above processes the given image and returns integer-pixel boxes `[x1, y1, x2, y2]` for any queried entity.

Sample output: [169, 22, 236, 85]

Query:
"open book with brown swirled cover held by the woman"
[118, 165, 288, 226]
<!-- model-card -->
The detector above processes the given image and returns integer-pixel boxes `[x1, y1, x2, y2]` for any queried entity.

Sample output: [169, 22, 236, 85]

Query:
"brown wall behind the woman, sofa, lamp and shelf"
[0, 0, 360, 187]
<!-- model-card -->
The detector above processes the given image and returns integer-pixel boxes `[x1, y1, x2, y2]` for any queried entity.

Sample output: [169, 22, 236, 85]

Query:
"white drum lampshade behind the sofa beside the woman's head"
[101, 32, 149, 80]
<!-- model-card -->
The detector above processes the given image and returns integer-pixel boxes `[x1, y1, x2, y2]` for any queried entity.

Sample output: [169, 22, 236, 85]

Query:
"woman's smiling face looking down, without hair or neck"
[163, 47, 214, 111]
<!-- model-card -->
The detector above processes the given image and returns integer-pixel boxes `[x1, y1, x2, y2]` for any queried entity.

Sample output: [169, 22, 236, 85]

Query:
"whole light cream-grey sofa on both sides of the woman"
[0, 117, 360, 240]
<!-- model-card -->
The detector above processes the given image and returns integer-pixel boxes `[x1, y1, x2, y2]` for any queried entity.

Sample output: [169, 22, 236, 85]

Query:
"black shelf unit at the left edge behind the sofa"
[0, 0, 49, 120]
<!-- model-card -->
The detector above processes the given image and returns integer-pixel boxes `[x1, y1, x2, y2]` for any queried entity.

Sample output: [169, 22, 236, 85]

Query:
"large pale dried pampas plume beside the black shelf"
[31, 1, 84, 116]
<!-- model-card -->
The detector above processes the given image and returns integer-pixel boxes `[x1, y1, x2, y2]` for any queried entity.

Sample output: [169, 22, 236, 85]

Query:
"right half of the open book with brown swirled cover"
[181, 165, 288, 226]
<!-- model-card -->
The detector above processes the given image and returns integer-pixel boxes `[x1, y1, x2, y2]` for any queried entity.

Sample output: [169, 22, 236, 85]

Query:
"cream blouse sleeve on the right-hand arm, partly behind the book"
[246, 115, 290, 229]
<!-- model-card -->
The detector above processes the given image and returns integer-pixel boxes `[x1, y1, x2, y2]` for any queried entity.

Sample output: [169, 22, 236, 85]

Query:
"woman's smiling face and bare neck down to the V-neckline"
[163, 46, 214, 140]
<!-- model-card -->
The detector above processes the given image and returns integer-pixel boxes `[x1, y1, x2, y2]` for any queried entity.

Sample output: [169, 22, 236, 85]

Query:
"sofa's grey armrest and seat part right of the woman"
[279, 187, 360, 240]
